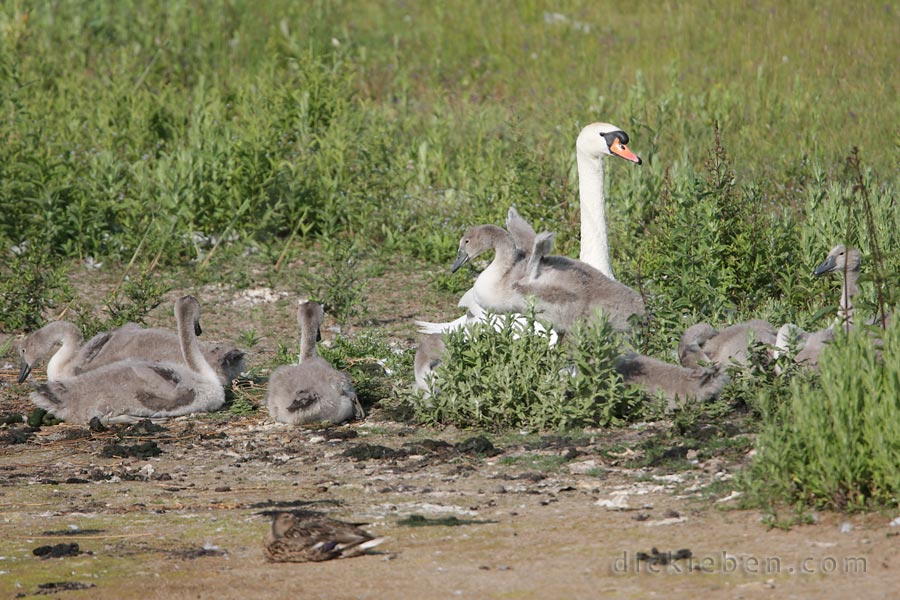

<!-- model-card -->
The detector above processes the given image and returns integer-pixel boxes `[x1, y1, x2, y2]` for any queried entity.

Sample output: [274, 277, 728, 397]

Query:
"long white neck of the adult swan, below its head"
[576, 151, 615, 280]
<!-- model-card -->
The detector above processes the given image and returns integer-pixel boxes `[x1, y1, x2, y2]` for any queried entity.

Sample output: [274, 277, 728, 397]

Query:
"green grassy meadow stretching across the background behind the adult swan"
[0, 1, 900, 268]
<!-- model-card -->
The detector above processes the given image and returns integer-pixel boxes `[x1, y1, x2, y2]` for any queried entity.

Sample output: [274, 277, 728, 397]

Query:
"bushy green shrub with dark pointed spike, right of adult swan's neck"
[636, 129, 800, 353]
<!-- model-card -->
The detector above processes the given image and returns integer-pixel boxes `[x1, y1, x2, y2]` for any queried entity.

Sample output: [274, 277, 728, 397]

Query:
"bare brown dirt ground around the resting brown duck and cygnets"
[0, 255, 900, 600]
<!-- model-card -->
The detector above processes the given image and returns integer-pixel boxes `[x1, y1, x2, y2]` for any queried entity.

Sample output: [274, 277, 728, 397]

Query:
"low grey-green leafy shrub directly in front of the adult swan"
[415, 317, 641, 430]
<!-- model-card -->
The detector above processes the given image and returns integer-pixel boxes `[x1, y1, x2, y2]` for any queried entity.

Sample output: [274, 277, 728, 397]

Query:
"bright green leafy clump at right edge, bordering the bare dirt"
[746, 320, 900, 510]
